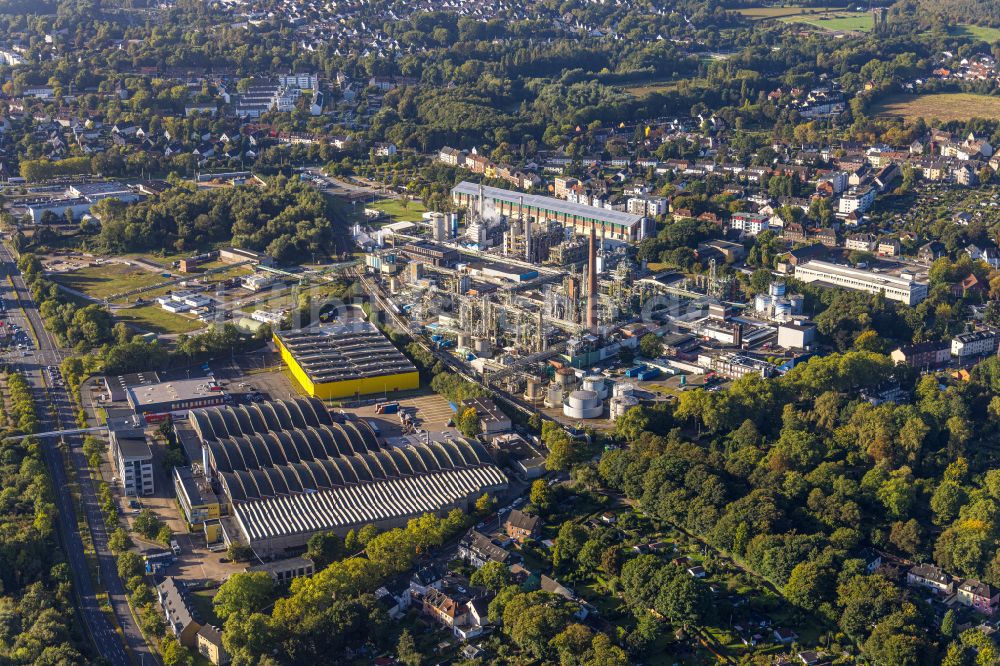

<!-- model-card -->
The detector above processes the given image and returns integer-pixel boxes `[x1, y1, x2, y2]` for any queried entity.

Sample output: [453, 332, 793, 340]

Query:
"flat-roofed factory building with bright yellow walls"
[274, 321, 420, 400]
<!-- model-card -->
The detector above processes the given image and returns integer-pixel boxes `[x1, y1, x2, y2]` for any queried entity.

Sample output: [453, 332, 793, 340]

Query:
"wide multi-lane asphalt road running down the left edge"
[0, 243, 159, 666]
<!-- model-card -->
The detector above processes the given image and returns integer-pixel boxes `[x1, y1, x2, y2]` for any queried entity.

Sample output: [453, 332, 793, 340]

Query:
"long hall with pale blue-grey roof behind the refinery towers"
[451, 180, 646, 243]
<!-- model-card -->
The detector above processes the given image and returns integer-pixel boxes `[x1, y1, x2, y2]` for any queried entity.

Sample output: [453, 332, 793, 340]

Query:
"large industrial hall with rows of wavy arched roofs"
[191, 398, 508, 559]
